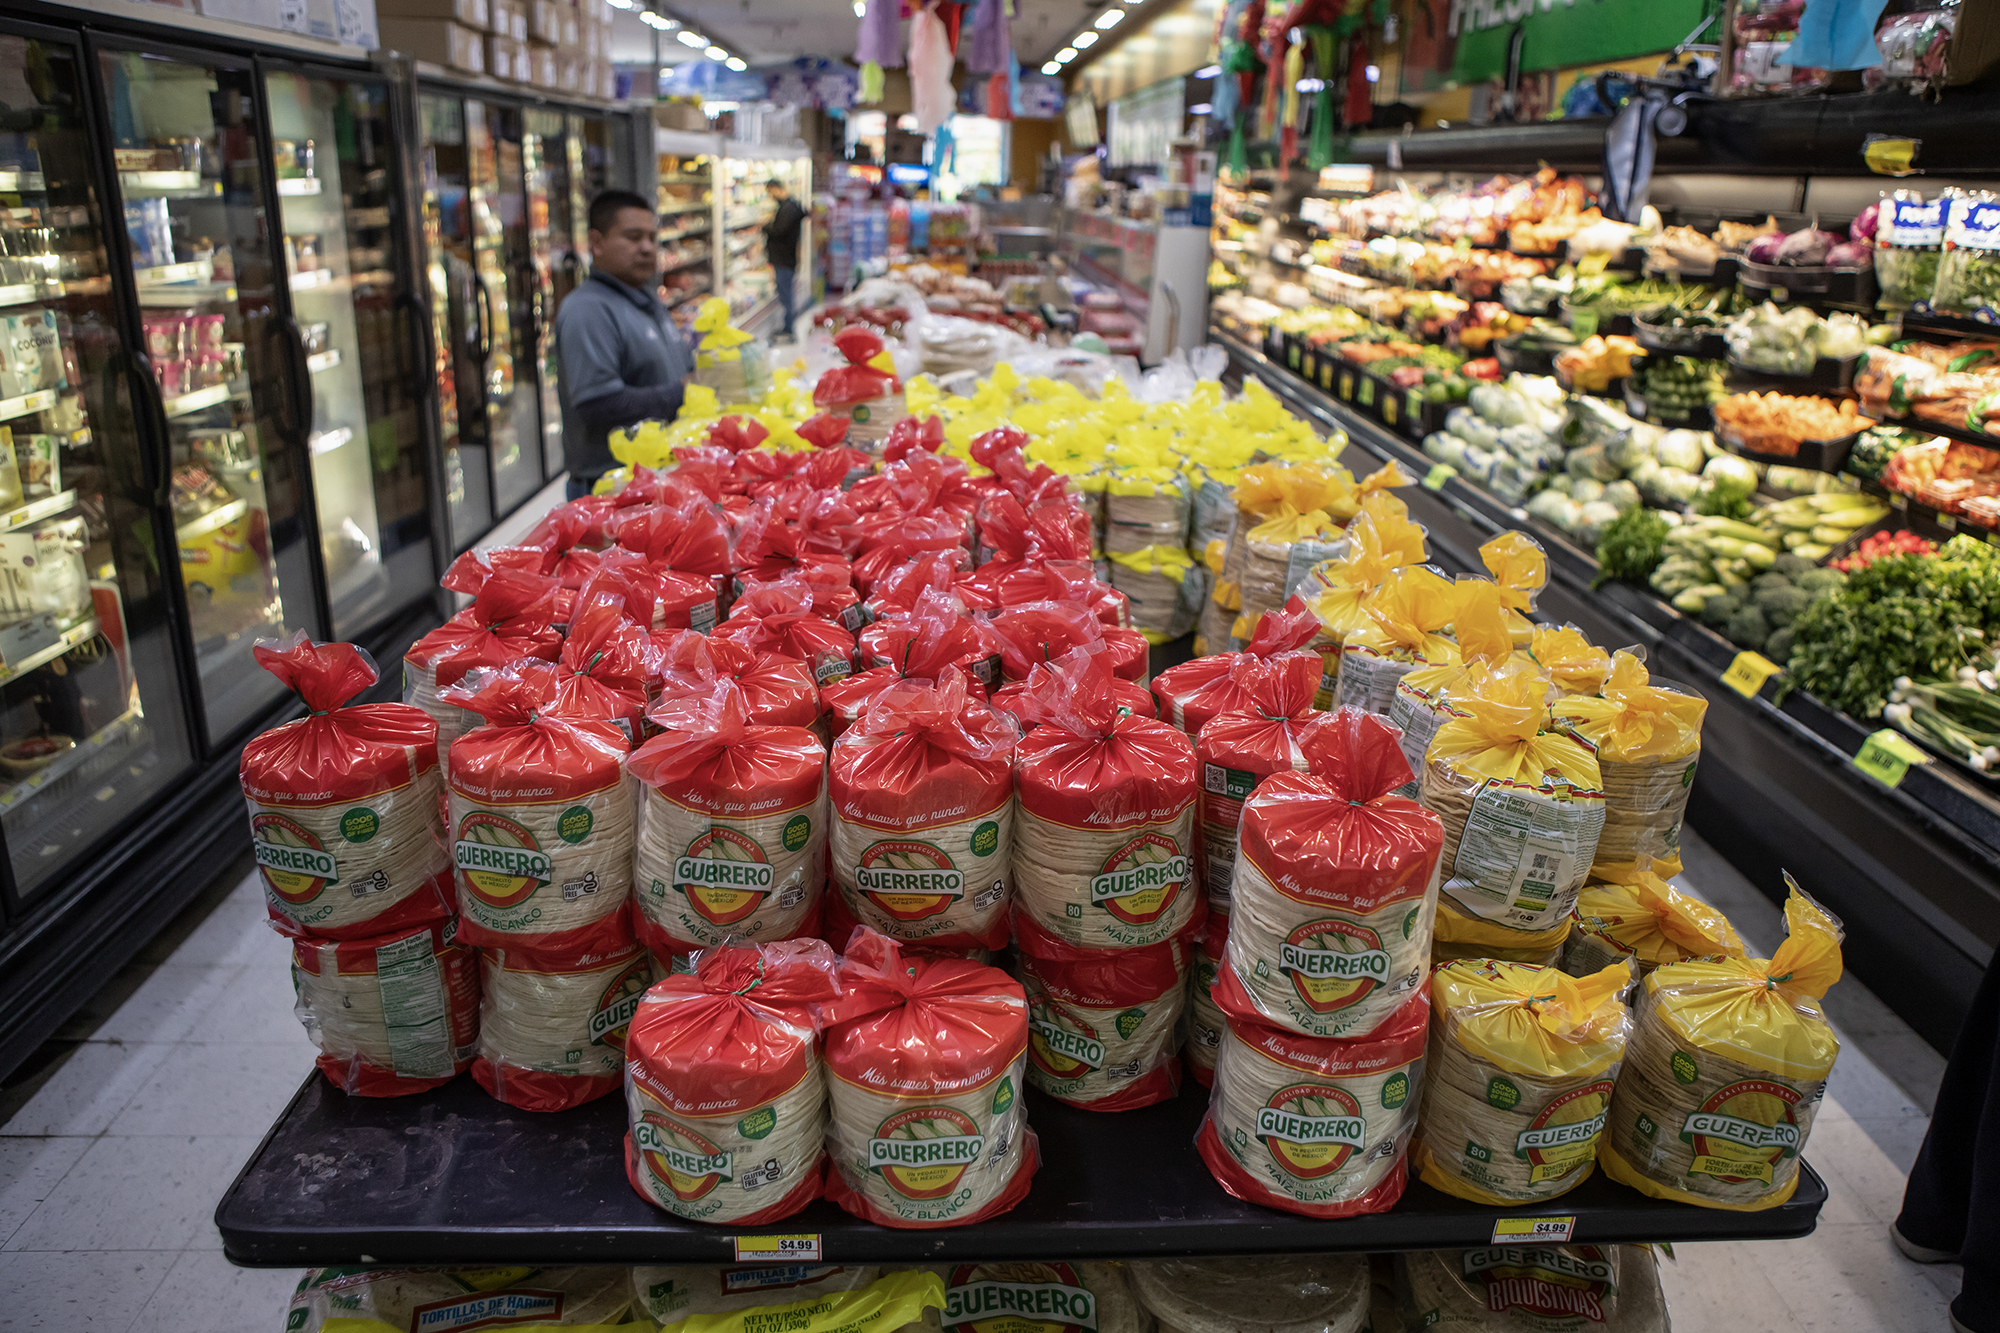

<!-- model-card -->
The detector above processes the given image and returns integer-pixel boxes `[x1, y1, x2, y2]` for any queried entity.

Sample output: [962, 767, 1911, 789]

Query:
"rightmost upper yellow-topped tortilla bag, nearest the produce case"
[1552, 652, 1708, 879]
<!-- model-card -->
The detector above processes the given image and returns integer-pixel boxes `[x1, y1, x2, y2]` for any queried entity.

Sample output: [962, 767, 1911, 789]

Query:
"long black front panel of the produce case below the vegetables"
[1210, 330, 2000, 1049]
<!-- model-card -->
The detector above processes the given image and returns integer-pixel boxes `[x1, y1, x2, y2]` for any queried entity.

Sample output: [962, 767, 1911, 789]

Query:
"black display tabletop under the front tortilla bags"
[216, 1071, 1826, 1267]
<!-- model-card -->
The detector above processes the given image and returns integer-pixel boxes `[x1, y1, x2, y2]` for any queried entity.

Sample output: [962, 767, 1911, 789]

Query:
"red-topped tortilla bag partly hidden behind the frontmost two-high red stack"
[1194, 652, 1320, 917]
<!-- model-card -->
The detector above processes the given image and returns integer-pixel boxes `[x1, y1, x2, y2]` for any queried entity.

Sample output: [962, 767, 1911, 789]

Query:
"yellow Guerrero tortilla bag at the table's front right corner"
[1598, 875, 1840, 1213]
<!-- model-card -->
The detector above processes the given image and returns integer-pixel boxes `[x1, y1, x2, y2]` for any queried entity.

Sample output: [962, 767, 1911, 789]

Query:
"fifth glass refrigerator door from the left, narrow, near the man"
[478, 102, 542, 514]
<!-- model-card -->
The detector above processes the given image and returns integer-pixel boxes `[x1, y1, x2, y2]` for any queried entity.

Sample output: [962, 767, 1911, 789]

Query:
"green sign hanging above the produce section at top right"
[1446, 0, 1716, 84]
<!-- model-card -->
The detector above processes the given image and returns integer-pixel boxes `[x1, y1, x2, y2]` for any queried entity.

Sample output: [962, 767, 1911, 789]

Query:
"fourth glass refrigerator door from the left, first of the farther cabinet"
[418, 94, 494, 554]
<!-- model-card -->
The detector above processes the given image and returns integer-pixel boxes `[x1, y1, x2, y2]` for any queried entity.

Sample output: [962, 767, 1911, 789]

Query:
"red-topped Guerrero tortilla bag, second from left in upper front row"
[444, 671, 634, 955]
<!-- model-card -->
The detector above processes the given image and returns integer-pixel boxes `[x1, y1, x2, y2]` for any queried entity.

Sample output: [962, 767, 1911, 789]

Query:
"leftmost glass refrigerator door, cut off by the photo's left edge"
[0, 30, 192, 903]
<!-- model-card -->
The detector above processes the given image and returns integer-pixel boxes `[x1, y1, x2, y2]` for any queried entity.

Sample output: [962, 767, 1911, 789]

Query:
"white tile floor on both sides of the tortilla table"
[0, 824, 1958, 1333]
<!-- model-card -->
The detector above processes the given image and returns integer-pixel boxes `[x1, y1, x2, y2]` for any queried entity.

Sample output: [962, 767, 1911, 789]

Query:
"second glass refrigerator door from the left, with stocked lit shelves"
[100, 50, 324, 747]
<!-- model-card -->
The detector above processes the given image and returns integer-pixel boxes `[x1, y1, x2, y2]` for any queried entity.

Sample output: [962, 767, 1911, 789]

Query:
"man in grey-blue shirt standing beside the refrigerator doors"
[556, 190, 694, 500]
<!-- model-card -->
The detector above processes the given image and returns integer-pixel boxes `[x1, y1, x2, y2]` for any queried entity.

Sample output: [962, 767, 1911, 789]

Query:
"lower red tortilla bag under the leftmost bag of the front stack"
[292, 921, 480, 1097]
